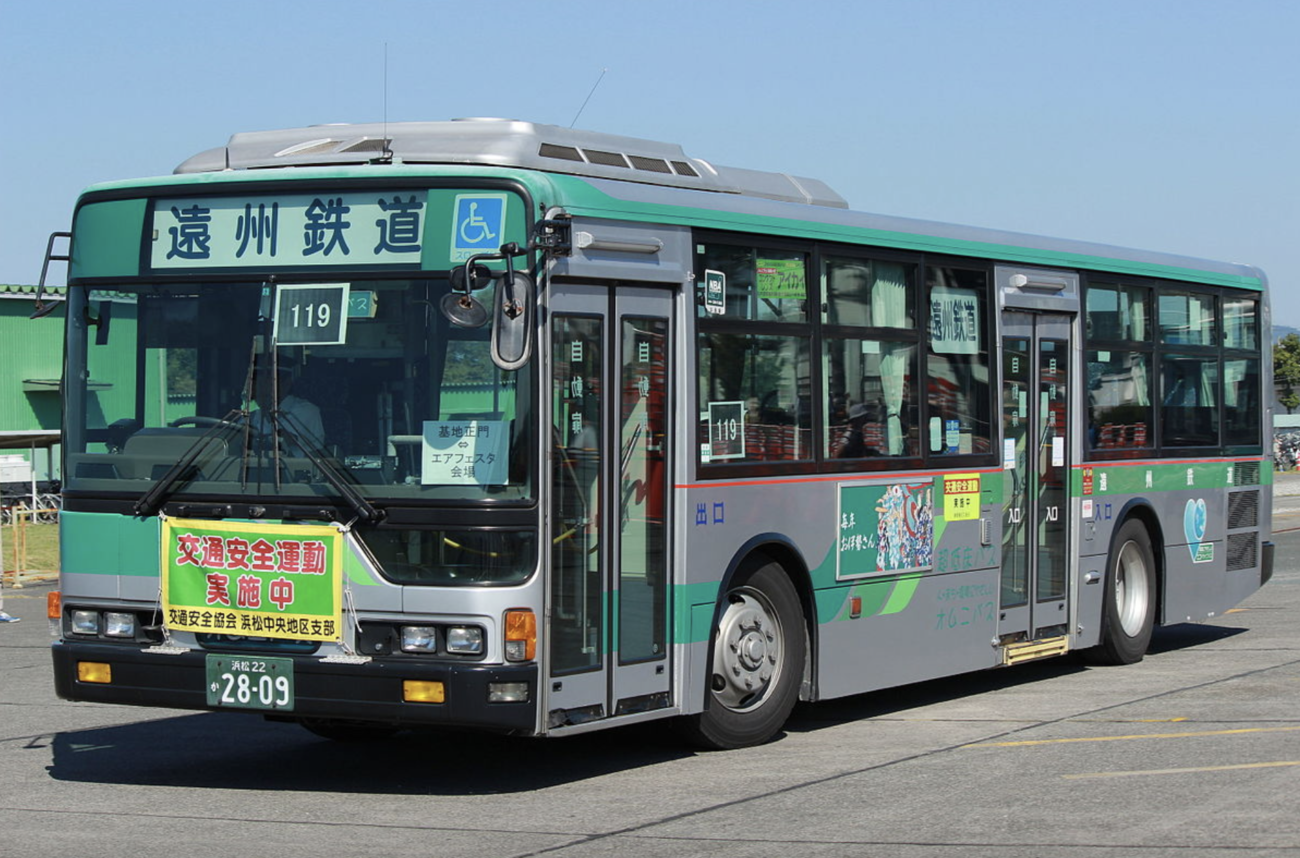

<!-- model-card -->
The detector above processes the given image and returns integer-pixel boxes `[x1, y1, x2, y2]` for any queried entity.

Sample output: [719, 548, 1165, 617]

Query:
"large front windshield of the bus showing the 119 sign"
[65, 278, 534, 504]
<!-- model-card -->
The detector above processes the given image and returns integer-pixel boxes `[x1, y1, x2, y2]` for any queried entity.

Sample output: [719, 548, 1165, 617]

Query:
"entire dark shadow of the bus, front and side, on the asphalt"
[48, 624, 1248, 796]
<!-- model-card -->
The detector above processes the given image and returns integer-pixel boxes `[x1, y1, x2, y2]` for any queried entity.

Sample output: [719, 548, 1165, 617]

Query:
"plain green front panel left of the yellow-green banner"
[59, 512, 163, 577]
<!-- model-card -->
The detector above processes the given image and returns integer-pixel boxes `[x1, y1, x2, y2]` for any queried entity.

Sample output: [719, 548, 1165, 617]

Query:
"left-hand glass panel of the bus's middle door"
[1002, 337, 1031, 608]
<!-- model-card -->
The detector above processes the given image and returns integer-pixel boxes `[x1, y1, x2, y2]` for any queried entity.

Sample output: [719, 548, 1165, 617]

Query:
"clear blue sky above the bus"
[0, 0, 1300, 326]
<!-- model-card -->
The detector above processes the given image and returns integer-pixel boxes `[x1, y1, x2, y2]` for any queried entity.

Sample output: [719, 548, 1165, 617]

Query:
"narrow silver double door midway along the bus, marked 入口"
[998, 311, 1076, 646]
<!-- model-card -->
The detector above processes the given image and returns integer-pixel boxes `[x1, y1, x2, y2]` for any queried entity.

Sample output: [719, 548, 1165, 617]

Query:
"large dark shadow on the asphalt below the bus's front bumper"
[48, 712, 694, 796]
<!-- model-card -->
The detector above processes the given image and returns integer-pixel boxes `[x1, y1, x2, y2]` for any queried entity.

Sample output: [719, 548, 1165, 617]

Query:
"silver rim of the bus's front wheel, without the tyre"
[712, 588, 785, 712]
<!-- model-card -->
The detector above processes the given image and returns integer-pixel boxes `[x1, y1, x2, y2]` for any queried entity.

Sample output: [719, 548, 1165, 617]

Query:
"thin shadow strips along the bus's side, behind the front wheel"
[785, 623, 1249, 733]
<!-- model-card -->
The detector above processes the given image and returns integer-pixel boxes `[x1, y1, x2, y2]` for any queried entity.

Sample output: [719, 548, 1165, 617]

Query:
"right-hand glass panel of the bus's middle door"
[1036, 339, 1070, 602]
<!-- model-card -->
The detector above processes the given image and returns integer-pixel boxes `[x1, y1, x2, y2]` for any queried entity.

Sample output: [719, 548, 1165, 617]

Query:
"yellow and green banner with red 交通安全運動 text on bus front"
[161, 519, 345, 641]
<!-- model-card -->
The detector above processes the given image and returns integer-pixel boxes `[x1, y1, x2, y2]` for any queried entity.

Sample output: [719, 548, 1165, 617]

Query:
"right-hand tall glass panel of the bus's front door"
[616, 319, 668, 663]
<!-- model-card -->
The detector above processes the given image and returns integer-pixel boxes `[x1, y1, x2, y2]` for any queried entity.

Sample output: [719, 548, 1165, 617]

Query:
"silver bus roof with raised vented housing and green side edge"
[101, 118, 1266, 289]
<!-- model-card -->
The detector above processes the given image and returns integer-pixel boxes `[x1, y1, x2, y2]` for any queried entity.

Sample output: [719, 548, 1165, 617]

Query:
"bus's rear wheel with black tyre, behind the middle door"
[1093, 519, 1156, 664]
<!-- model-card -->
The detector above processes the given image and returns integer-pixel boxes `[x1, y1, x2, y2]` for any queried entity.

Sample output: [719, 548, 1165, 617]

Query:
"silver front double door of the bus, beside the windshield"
[543, 283, 675, 729]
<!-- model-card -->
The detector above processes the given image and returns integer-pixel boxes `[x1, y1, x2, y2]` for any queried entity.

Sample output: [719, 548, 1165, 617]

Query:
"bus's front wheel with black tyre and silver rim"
[685, 563, 806, 749]
